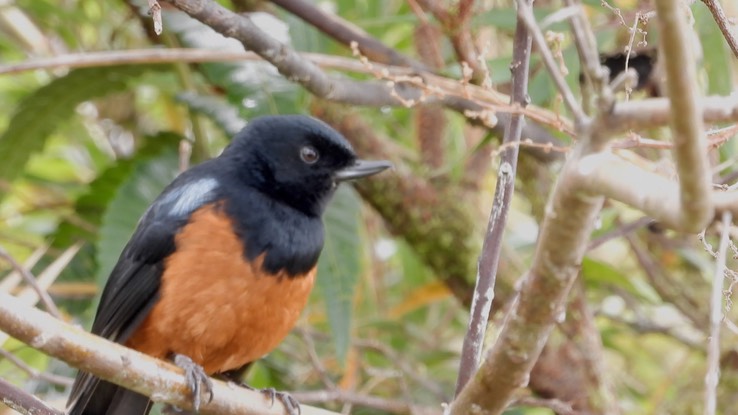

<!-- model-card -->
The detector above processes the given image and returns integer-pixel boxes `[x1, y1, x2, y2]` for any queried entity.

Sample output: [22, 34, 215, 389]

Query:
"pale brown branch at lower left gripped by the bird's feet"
[0, 293, 333, 415]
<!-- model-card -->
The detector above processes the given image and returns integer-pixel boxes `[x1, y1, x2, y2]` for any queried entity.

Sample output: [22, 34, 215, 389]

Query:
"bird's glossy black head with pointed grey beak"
[221, 115, 391, 216]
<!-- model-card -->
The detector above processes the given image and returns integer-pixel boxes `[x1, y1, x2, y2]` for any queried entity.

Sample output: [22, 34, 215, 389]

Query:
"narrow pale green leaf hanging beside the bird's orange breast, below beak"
[317, 186, 361, 362]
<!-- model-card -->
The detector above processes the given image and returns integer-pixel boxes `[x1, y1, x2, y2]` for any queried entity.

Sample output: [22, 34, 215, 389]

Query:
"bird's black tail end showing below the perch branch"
[68, 372, 151, 415]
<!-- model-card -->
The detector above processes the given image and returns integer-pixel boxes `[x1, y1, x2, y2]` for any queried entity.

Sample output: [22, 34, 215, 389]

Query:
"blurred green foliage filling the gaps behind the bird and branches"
[0, 0, 738, 414]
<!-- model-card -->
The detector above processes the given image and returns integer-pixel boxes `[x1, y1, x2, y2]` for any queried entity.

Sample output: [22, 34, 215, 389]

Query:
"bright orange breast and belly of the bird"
[126, 205, 316, 374]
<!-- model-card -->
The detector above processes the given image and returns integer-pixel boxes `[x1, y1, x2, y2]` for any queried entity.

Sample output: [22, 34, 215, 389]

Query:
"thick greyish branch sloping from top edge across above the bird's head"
[161, 0, 572, 160]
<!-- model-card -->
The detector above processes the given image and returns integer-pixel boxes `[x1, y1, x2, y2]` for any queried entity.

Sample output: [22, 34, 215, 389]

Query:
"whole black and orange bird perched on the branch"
[69, 115, 390, 415]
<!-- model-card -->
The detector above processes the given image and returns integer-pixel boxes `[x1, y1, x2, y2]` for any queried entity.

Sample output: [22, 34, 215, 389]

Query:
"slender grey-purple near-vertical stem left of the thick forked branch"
[456, 0, 531, 395]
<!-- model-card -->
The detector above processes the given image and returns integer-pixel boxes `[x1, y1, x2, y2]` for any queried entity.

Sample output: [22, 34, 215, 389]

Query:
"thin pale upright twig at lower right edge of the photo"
[703, 212, 733, 415]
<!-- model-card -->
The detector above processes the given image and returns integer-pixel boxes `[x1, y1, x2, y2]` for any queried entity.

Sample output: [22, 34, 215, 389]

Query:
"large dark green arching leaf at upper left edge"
[0, 65, 160, 192]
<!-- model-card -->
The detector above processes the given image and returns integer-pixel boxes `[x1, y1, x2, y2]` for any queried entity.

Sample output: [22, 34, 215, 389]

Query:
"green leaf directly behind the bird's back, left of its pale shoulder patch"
[96, 149, 179, 285]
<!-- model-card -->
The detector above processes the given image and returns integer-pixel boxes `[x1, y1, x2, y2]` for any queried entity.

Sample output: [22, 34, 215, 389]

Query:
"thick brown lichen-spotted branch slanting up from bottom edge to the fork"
[450, 4, 609, 415]
